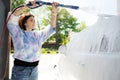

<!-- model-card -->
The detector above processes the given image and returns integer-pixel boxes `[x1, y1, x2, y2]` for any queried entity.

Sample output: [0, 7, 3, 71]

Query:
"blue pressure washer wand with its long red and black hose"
[0, 1, 79, 80]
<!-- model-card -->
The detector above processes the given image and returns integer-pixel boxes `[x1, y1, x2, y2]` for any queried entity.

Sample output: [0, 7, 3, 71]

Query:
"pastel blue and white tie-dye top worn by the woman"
[8, 15, 55, 62]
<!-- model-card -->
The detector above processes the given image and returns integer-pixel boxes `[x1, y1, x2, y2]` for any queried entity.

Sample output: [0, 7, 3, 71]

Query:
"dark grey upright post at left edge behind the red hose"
[0, 0, 10, 80]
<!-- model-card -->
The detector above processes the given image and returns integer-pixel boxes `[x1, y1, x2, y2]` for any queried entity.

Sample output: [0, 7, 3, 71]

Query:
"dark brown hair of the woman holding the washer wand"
[18, 14, 34, 30]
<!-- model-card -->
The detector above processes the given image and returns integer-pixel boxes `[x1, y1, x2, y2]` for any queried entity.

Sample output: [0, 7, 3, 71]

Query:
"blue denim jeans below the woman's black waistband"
[11, 65, 38, 80]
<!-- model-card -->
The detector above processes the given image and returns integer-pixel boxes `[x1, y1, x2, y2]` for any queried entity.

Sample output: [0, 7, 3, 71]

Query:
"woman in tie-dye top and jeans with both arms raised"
[8, 2, 58, 80]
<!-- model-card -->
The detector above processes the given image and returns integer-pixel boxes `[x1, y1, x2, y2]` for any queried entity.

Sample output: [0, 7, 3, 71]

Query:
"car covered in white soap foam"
[58, 16, 120, 80]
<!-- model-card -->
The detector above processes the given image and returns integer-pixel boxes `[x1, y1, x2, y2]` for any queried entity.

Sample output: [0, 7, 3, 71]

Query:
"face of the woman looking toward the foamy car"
[25, 16, 35, 31]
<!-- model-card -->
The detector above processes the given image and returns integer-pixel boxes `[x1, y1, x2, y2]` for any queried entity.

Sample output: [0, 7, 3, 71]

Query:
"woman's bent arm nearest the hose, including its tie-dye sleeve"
[7, 6, 28, 37]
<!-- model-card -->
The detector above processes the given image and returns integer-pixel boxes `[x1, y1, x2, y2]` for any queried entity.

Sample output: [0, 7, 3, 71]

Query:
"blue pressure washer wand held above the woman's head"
[27, 1, 79, 9]
